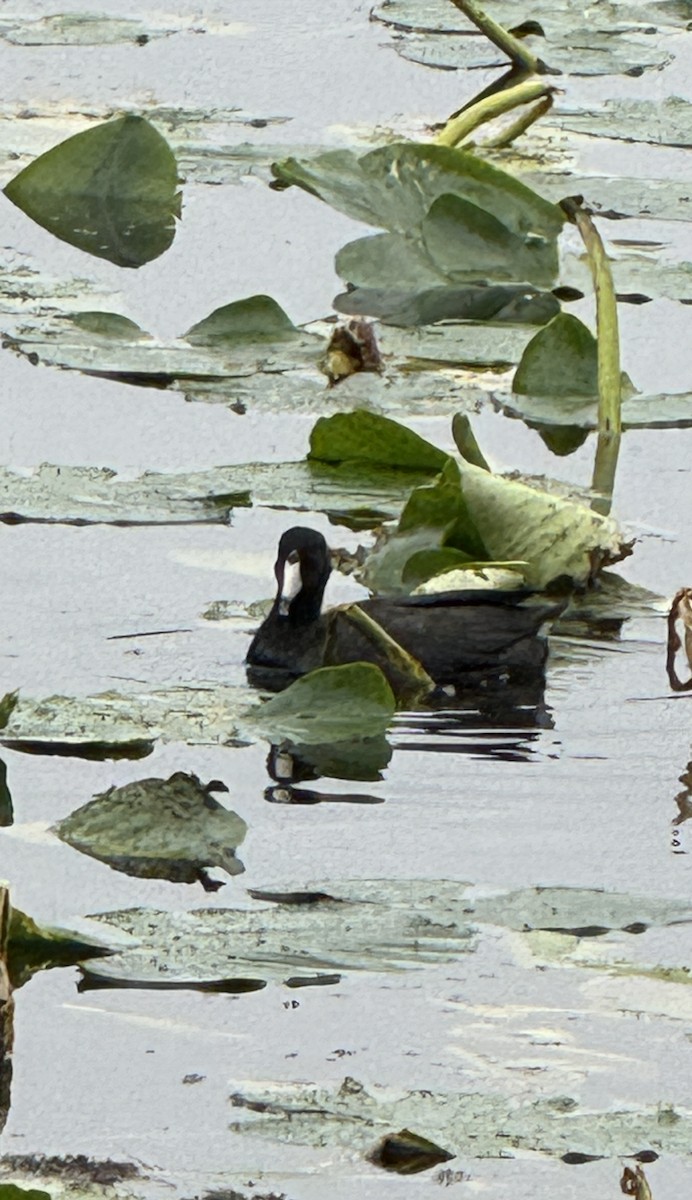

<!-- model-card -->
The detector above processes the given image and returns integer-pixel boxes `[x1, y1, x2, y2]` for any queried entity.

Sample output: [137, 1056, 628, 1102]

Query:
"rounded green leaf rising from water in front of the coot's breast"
[245, 662, 396, 745]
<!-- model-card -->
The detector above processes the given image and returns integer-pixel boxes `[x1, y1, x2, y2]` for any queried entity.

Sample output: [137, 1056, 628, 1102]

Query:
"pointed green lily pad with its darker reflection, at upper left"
[5, 116, 180, 268]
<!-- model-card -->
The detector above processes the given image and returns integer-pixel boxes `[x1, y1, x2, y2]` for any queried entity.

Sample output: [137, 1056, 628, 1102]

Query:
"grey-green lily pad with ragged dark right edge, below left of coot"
[54, 772, 247, 890]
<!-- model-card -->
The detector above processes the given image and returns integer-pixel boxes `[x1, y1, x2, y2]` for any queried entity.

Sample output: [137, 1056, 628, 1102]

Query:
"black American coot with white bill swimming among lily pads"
[246, 526, 562, 703]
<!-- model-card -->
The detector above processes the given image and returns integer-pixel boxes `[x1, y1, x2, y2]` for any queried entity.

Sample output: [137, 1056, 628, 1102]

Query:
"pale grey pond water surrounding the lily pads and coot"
[0, 0, 692, 1200]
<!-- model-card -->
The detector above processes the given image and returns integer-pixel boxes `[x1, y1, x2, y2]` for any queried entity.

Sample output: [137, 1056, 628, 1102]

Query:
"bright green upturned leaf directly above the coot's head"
[308, 409, 447, 472]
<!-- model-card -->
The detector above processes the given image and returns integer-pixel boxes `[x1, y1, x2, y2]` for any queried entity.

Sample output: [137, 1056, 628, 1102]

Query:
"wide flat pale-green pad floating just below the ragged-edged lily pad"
[80, 880, 474, 988]
